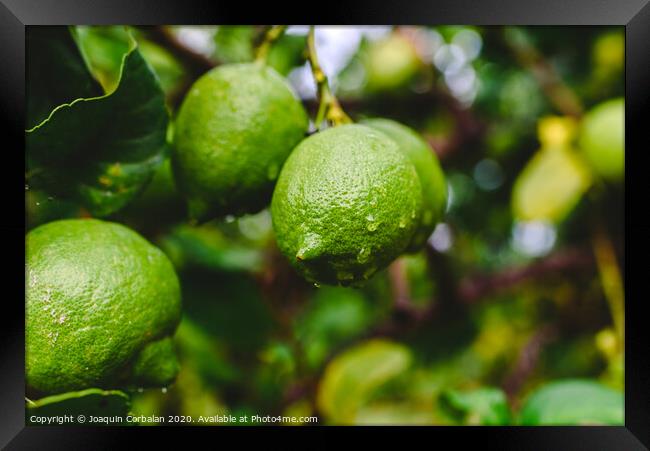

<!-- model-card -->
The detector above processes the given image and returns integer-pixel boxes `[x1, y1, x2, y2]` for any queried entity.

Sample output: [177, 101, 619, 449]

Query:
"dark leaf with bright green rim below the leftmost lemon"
[25, 388, 130, 424]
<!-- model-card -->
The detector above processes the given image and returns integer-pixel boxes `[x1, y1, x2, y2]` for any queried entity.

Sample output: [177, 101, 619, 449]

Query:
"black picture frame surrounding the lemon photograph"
[0, 0, 650, 450]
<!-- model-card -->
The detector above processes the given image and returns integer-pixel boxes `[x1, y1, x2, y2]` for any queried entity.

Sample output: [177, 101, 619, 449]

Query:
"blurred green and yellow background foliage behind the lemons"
[26, 26, 625, 425]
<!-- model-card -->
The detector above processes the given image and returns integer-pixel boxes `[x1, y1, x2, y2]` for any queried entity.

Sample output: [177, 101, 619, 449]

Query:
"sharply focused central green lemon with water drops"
[271, 124, 422, 286]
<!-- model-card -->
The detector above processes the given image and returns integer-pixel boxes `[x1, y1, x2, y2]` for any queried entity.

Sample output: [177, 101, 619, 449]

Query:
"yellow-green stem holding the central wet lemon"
[307, 25, 352, 130]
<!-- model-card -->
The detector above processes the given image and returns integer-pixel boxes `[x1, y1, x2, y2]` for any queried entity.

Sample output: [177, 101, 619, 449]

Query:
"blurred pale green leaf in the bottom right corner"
[520, 379, 624, 426]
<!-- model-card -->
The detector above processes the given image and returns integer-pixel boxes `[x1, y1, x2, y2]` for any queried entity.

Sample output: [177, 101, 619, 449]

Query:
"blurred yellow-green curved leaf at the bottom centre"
[317, 339, 412, 424]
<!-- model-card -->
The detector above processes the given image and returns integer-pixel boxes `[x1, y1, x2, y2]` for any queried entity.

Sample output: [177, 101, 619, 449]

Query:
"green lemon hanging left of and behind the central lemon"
[173, 63, 309, 220]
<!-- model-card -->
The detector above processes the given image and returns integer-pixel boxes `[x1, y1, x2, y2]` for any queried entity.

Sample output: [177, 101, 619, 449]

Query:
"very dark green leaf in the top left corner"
[25, 26, 102, 127]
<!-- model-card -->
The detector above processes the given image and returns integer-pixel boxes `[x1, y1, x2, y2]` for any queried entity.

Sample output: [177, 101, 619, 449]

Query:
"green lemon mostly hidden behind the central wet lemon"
[361, 119, 447, 252]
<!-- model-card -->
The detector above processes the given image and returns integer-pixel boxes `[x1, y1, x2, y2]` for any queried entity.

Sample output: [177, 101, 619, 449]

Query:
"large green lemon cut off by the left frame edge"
[25, 219, 181, 395]
